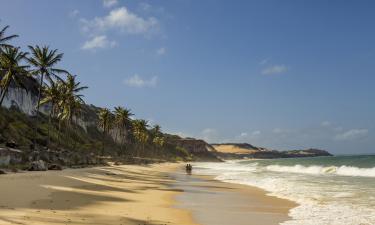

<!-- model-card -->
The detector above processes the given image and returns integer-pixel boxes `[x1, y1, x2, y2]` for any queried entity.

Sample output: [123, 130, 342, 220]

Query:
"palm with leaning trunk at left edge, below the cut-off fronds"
[0, 47, 28, 106]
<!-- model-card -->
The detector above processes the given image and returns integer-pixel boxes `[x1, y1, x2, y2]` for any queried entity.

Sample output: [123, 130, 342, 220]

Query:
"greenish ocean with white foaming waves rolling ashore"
[194, 155, 375, 225]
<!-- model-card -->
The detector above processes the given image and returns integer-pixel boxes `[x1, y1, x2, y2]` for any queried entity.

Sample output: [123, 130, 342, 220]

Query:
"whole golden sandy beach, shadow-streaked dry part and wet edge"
[0, 164, 294, 225]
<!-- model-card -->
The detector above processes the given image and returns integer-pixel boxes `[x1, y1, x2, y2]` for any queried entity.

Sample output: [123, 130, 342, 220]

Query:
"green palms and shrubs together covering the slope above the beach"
[0, 23, 192, 163]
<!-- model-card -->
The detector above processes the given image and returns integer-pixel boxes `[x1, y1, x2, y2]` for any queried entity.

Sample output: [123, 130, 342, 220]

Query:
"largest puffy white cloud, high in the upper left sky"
[81, 7, 159, 34]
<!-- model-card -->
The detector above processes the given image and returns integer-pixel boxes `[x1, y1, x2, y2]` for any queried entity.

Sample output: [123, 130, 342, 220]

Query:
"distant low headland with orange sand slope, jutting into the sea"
[212, 143, 332, 160]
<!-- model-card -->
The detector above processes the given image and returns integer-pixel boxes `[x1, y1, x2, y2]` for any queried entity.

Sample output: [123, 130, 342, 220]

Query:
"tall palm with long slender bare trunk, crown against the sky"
[28, 45, 67, 146]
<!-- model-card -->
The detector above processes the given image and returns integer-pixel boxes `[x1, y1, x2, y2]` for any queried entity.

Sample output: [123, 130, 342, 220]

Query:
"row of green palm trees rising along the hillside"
[0, 23, 165, 156]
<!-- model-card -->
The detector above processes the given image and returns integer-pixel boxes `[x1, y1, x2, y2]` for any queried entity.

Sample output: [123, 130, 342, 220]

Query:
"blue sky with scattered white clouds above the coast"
[0, 0, 375, 154]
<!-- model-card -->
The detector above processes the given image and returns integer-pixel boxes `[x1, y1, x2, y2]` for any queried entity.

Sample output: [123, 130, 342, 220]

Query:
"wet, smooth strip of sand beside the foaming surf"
[174, 165, 298, 225]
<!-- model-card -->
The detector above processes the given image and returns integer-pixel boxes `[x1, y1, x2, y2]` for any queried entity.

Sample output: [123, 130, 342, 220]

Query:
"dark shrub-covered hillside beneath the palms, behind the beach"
[0, 105, 218, 167]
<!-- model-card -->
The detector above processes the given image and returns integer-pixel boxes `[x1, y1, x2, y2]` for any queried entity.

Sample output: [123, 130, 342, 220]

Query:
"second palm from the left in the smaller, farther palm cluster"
[114, 106, 134, 151]
